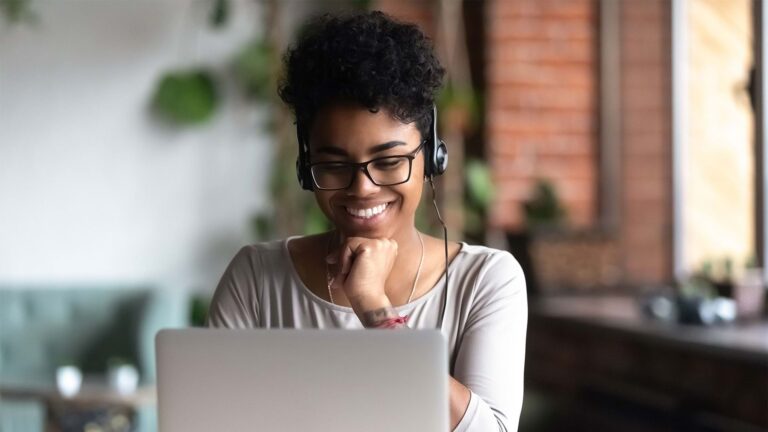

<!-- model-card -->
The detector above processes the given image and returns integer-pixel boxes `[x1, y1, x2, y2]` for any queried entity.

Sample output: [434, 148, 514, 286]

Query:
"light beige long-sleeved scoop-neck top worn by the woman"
[208, 237, 528, 432]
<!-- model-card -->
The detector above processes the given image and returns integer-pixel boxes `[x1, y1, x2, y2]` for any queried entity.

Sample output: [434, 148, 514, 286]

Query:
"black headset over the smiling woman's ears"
[296, 105, 448, 191]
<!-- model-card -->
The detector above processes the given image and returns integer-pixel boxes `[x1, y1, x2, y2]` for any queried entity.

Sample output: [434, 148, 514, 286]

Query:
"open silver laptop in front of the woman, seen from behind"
[155, 328, 449, 432]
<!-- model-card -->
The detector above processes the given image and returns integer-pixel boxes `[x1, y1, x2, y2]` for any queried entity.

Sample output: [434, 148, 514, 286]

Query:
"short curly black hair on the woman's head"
[278, 11, 445, 137]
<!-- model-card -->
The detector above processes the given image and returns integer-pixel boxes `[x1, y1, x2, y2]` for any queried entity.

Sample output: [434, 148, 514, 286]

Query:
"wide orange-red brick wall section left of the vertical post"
[486, 0, 598, 230]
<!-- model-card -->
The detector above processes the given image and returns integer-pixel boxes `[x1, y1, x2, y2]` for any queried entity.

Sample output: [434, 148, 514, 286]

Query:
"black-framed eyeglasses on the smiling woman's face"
[309, 141, 425, 190]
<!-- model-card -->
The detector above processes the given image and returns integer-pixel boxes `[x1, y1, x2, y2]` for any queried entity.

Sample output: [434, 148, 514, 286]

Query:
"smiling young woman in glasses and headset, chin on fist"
[209, 12, 527, 431]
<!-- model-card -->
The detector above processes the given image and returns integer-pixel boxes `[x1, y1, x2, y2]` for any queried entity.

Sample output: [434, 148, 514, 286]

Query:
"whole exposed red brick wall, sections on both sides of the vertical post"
[374, 0, 672, 285]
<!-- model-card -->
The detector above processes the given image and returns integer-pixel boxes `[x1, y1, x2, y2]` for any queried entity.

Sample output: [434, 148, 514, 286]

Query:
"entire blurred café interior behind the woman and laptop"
[0, 0, 768, 432]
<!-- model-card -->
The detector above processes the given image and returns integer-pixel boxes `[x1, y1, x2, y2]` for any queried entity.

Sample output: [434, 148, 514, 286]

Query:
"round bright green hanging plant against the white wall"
[152, 69, 218, 126]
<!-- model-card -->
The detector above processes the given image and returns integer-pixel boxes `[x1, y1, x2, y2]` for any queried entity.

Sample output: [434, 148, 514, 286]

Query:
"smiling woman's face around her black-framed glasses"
[309, 104, 424, 238]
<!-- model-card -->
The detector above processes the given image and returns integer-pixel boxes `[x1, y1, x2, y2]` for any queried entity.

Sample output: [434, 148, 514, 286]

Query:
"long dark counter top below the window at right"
[530, 296, 768, 363]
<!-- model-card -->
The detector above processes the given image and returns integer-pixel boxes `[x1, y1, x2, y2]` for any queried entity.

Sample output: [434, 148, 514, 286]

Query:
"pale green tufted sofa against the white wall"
[0, 286, 189, 432]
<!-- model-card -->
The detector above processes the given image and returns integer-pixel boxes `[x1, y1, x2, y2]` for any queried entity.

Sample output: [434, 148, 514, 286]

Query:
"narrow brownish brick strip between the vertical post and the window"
[620, 0, 672, 284]
